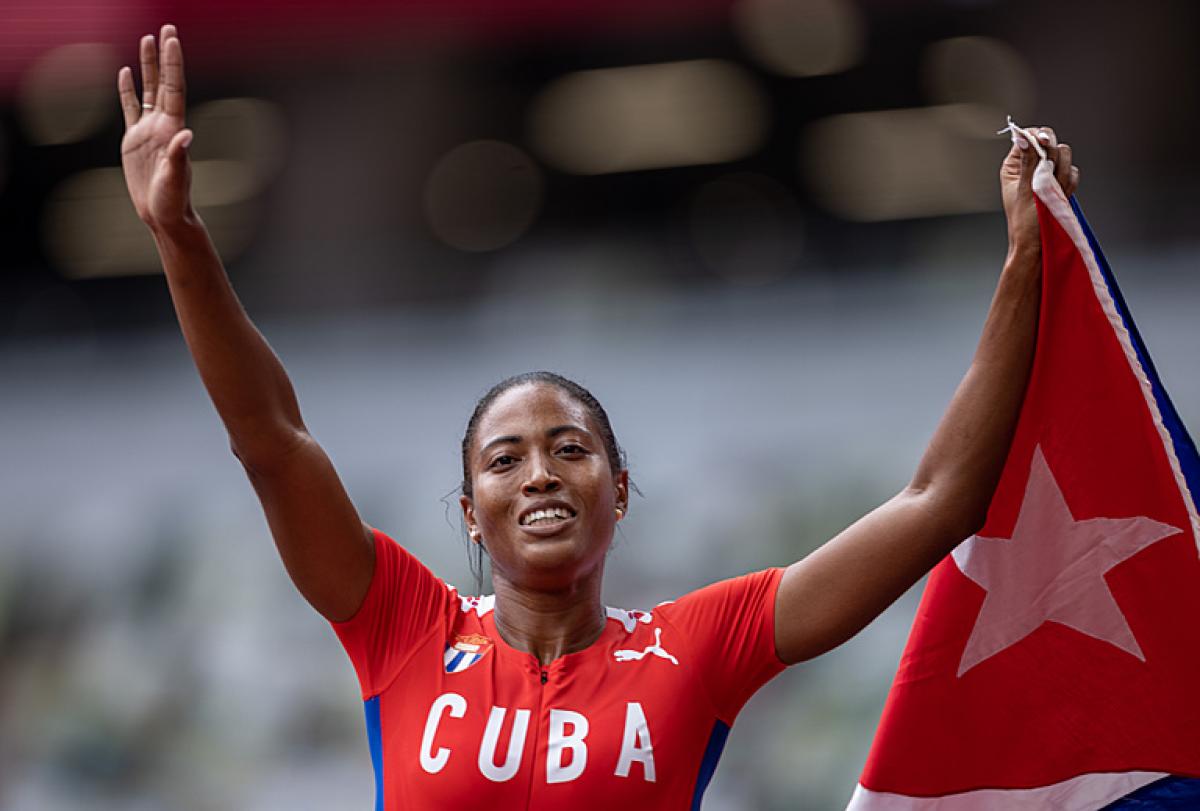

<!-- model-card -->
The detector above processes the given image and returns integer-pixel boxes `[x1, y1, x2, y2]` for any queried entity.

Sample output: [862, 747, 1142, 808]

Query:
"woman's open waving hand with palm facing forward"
[116, 25, 194, 230]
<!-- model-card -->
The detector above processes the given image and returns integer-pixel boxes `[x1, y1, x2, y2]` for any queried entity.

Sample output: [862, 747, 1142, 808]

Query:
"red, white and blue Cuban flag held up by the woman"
[848, 150, 1200, 811]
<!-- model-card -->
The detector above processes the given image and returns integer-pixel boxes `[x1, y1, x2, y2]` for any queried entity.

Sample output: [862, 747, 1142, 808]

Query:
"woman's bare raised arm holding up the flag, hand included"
[775, 127, 1079, 662]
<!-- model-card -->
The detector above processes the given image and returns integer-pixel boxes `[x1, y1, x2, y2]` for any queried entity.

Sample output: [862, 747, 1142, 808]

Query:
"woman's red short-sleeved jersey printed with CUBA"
[337, 532, 782, 811]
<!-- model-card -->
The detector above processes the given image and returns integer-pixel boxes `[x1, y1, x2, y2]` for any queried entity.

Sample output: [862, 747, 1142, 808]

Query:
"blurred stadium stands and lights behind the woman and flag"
[0, 0, 1200, 811]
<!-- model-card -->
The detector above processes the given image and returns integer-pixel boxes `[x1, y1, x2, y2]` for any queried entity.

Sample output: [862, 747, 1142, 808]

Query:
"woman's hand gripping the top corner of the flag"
[1000, 127, 1079, 253]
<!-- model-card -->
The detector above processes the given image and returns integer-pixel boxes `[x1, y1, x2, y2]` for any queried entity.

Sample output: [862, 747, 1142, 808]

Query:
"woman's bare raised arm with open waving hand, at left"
[118, 25, 374, 620]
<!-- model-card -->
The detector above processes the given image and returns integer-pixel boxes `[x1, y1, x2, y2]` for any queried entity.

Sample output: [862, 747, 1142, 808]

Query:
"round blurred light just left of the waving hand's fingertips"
[17, 42, 120, 145]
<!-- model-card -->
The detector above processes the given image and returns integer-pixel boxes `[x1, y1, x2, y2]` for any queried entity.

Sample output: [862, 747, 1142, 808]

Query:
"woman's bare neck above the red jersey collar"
[492, 573, 605, 665]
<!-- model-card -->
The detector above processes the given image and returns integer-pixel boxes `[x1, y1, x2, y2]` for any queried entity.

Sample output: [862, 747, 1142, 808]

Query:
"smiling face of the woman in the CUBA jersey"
[462, 383, 629, 589]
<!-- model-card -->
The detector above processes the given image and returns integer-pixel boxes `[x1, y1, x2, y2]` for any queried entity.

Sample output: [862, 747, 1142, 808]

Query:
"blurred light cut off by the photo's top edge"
[733, 0, 866, 77]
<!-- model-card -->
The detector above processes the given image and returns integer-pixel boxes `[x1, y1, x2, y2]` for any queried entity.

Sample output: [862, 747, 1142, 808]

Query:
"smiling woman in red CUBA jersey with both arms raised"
[118, 25, 1079, 809]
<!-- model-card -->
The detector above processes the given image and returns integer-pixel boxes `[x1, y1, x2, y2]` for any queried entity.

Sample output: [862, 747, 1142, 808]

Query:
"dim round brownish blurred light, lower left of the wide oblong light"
[425, 140, 542, 251]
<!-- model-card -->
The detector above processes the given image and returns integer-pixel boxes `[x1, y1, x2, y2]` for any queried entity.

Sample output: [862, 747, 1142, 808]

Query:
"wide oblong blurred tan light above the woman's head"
[530, 59, 768, 175]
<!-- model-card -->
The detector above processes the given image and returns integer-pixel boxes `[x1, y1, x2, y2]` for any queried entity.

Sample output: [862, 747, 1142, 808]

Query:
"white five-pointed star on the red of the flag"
[953, 445, 1180, 675]
